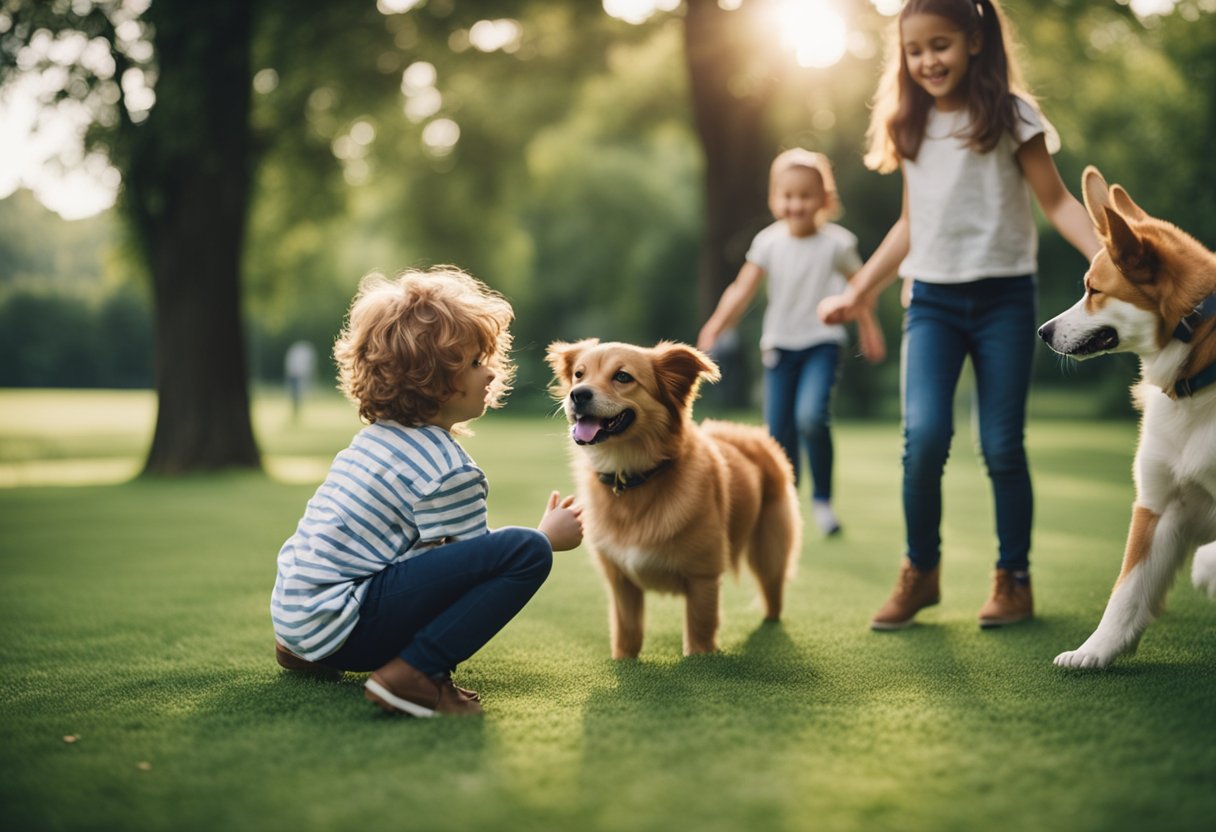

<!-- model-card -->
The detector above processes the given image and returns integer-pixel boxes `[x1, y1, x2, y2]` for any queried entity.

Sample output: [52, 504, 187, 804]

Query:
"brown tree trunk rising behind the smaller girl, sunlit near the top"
[685, 0, 773, 406]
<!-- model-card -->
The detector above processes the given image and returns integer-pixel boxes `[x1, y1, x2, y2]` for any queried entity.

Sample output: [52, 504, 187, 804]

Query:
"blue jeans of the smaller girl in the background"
[764, 343, 840, 500]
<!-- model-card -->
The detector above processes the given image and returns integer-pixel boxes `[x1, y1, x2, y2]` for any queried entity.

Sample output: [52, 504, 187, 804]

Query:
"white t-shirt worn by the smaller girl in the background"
[747, 220, 861, 349]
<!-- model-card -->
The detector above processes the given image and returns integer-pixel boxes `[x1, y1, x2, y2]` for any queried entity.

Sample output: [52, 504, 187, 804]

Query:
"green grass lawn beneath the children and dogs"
[0, 392, 1216, 832]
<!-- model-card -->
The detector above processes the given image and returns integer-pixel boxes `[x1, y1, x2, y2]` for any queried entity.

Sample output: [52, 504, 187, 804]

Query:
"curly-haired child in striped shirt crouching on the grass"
[270, 268, 582, 716]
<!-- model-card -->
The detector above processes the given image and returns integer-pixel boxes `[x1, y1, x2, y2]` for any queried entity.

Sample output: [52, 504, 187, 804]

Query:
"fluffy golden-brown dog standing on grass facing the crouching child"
[547, 338, 801, 659]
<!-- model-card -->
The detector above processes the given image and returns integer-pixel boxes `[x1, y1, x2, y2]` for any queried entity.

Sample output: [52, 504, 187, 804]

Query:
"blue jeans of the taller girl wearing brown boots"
[901, 275, 1037, 570]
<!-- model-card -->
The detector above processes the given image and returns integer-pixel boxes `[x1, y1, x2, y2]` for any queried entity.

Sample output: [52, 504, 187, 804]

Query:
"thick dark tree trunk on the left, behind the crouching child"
[125, 0, 260, 474]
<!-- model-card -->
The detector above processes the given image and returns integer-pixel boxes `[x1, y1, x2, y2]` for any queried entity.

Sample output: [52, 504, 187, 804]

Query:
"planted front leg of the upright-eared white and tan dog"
[1055, 505, 1182, 669]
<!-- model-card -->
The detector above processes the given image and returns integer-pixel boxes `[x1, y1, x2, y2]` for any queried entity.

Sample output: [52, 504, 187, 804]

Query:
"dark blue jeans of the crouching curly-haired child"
[321, 527, 553, 676]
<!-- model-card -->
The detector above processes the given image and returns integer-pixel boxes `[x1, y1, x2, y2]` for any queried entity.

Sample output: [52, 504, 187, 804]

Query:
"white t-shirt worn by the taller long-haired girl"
[900, 99, 1046, 283]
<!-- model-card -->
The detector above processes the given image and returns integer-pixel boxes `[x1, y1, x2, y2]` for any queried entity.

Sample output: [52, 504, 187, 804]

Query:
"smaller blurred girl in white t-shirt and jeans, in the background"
[697, 147, 885, 535]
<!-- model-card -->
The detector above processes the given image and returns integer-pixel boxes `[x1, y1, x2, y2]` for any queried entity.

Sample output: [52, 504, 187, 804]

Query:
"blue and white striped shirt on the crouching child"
[270, 421, 489, 662]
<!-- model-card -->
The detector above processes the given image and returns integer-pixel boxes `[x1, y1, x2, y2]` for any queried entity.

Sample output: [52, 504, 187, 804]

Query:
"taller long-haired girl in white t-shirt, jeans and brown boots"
[820, 0, 1099, 630]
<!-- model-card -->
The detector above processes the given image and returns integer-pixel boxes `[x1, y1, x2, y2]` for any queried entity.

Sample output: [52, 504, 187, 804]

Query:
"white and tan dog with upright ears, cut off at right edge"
[1038, 167, 1216, 668]
